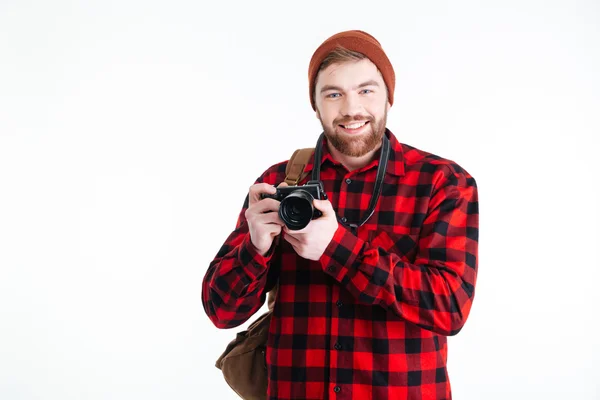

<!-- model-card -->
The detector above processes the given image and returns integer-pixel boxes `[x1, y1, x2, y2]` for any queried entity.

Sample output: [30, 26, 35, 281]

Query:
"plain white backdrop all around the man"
[0, 0, 600, 400]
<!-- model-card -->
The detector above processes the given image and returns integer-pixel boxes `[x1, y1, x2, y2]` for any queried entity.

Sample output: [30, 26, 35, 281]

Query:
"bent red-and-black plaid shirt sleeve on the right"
[319, 165, 479, 336]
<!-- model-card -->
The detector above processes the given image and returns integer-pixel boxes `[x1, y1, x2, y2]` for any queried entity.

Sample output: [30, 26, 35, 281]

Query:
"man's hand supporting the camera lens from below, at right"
[282, 199, 339, 261]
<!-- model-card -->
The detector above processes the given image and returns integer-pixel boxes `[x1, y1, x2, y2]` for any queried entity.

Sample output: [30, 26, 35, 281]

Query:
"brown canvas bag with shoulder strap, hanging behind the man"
[215, 148, 315, 400]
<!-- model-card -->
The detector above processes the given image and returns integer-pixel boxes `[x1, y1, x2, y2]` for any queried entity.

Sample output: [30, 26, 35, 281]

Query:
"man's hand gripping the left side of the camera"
[245, 183, 286, 256]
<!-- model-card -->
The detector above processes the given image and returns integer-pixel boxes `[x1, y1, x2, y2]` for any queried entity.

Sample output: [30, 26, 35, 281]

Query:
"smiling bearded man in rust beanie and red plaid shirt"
[202, 31, 479, 400]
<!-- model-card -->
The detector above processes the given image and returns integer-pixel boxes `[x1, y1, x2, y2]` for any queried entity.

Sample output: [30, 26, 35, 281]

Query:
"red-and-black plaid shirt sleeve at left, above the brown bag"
[202, 178, 275, 329]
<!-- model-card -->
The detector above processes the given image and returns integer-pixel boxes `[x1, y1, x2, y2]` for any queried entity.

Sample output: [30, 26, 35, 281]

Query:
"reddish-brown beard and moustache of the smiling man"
[319, 109, 387, 157]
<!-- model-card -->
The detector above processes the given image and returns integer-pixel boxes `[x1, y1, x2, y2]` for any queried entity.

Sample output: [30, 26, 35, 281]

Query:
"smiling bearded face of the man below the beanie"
[315, 59, 390, 157]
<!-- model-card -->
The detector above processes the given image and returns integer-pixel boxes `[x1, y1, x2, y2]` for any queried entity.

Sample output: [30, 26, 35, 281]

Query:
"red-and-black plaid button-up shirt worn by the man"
[202, 130, 479, 400]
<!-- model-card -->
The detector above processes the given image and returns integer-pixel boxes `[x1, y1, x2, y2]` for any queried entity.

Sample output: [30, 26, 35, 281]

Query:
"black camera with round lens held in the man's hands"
[261, 181, 327, 230]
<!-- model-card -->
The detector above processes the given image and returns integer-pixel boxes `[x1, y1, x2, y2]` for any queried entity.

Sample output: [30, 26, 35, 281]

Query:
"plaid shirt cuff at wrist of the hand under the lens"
[319, 224, 365, 282]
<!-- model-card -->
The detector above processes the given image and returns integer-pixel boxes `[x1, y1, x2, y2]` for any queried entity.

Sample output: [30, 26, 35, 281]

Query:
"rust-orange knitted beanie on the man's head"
[308, 30, 396, 110]
